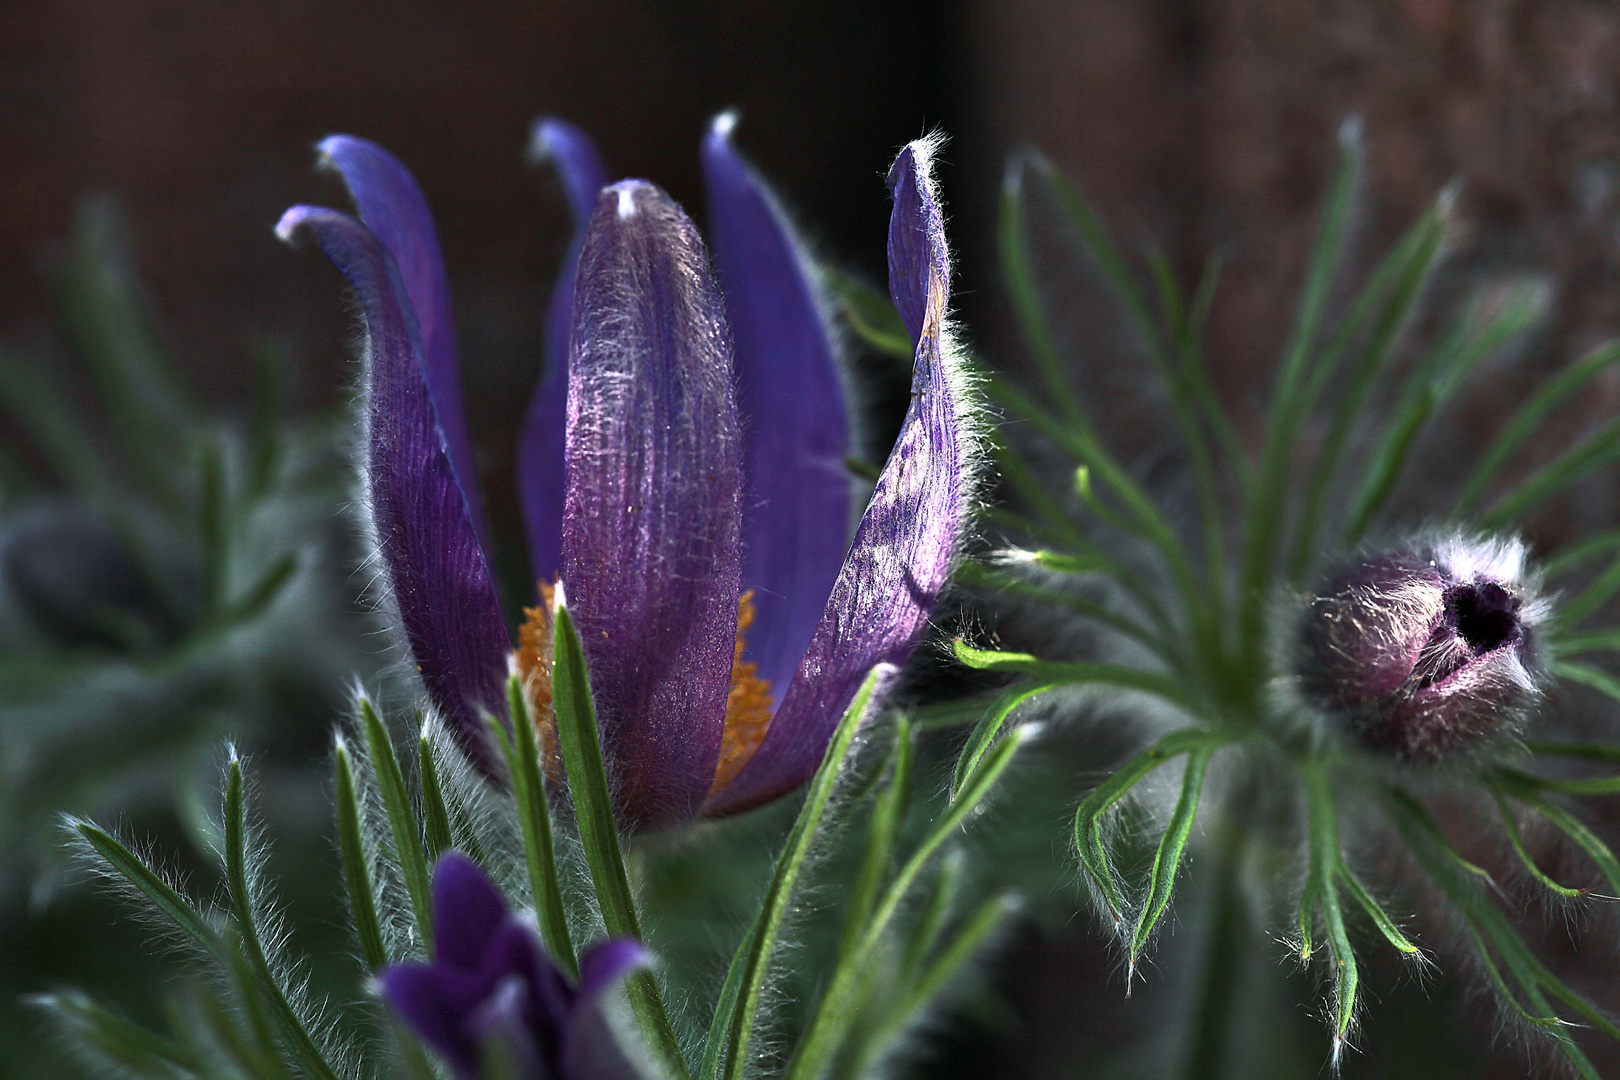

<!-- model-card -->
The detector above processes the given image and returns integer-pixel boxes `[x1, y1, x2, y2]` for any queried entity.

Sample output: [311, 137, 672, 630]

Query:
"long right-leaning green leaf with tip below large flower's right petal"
[698, 667, 910, 1080]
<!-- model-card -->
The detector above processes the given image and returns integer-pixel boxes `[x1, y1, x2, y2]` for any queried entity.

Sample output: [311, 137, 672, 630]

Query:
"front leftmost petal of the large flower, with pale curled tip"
[275, 206, 510, 767]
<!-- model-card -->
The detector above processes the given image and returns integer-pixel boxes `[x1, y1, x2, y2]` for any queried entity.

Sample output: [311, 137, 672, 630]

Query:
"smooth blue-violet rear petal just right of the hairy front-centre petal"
[703, 113, 849, 701]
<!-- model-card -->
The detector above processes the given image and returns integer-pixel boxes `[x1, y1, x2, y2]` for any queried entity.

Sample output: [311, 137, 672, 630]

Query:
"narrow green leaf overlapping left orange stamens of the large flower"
[551, 604, 687, 1078]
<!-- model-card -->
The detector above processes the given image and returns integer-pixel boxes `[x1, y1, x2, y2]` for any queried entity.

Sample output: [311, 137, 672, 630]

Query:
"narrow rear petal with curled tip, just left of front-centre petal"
[517, 117, 608, 581]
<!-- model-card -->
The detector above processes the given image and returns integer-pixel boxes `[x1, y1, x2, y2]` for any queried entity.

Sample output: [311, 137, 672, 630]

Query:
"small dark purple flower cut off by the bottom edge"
[377, 852, 648, 1080]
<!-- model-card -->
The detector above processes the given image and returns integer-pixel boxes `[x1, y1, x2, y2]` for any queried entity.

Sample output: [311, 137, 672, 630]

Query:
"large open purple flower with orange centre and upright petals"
[277, 117, 969, 826]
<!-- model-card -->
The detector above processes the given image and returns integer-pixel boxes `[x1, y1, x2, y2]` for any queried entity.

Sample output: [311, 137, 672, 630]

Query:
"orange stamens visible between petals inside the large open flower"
[515, 581, 773, 793]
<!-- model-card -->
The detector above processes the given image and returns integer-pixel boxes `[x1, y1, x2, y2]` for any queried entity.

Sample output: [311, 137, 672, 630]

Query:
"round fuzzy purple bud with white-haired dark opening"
[1293, 538, 1547, 763]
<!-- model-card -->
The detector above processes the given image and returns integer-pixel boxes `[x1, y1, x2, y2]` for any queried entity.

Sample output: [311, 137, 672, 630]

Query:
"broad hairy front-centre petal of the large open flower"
[562, 180, 742, 824]
